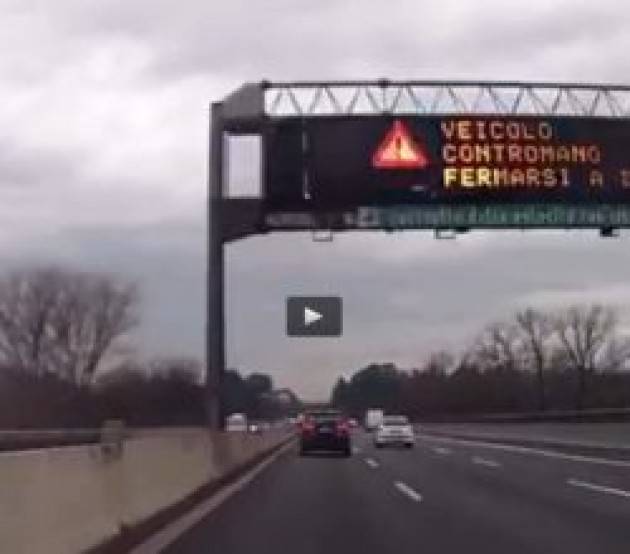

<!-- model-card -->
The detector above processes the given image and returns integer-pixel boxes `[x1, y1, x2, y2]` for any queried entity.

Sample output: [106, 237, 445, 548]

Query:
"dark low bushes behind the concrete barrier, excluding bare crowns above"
[0, 358, 301, 429]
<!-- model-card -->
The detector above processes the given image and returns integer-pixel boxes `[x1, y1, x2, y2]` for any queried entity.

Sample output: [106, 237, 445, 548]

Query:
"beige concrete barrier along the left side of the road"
[0, 428, 288, 554]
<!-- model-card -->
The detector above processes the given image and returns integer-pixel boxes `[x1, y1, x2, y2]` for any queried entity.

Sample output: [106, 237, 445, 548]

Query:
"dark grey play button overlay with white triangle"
[287, 296, 343, 337]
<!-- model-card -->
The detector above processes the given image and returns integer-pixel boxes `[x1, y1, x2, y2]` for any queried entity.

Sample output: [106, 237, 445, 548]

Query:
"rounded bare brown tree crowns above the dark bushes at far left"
[0, 269, 138, 384]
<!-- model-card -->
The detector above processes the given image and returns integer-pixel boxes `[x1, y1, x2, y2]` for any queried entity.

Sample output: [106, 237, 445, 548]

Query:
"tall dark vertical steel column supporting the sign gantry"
[206, 103, 225, 430]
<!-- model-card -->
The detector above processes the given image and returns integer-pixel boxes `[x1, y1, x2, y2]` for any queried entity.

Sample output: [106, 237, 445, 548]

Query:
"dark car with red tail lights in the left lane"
[300, 410, 352, 456]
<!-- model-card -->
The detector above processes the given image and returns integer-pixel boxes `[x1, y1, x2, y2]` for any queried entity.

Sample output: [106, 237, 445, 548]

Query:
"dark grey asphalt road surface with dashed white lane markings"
[165, 432, 630, 554]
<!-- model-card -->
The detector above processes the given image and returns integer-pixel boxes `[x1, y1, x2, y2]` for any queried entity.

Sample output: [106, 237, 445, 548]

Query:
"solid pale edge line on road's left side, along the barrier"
[129, 440, 295, 554]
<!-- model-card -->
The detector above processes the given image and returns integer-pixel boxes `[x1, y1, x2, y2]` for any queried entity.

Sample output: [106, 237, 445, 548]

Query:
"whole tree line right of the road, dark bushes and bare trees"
[331, 304, 630, 417]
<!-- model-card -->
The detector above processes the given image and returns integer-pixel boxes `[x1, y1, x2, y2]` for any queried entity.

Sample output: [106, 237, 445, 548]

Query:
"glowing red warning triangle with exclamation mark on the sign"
[372, 120, 429, 169]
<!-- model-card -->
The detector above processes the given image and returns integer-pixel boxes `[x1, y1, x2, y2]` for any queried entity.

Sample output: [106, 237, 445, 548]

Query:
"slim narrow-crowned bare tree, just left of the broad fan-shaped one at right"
[516, 308, 553, 410]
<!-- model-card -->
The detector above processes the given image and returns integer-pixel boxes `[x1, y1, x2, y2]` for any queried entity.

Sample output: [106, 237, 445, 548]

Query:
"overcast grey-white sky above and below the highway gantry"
[0, 0, 630, 398]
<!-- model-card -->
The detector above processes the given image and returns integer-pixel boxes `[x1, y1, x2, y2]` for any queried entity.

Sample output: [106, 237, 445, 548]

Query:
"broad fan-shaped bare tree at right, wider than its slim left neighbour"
[554, 305, 617, 410]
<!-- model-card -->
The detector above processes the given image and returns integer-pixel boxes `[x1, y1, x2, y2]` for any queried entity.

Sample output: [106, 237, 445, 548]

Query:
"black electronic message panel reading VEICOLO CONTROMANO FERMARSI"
[264, 115, 630, 210]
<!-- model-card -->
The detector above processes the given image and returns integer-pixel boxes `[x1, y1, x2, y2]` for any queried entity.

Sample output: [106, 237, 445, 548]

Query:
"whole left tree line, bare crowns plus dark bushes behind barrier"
[0, 268, 299, 429]
